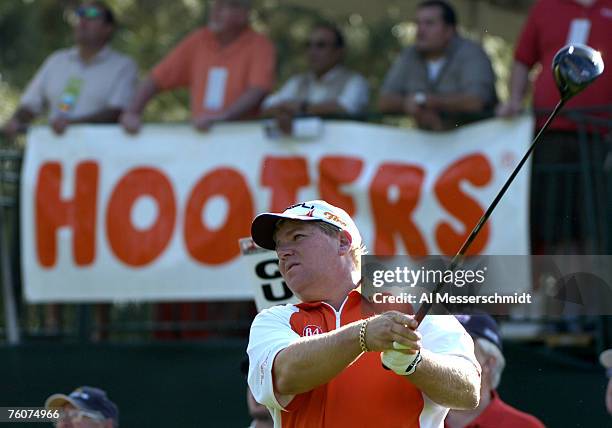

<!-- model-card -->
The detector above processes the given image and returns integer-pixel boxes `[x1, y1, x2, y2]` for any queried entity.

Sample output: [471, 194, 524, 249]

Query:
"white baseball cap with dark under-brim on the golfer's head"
[251, 200, 361, 250]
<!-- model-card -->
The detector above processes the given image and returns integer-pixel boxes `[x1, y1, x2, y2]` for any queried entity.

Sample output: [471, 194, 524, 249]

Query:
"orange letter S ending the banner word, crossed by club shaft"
[434, 154, 493, 255]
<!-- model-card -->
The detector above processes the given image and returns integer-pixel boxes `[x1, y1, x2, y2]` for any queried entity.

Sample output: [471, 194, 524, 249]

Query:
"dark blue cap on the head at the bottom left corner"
[45, 386, 119, 426]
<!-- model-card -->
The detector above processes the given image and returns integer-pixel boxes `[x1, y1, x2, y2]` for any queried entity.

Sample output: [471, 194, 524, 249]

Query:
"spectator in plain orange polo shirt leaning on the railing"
[121, 0, 276, 133]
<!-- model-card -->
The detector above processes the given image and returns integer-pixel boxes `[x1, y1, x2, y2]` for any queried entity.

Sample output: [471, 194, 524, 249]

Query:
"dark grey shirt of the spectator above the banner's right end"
[381, 36, 497, 128]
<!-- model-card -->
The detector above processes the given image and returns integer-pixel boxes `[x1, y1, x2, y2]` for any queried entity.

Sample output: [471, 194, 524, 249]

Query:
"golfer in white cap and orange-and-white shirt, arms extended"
[247, 200, 480, 428]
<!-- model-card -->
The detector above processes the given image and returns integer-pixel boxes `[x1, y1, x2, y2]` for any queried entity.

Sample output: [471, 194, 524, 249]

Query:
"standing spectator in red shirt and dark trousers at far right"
[497, 0, 612, 254]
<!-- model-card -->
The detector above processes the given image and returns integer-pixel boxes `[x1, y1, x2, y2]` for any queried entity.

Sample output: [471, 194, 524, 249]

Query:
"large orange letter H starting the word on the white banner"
[34, 161, 99, 268]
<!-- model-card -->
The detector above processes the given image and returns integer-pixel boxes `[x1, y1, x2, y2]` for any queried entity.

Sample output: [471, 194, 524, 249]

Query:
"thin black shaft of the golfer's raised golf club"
[415, 99, 567, 324]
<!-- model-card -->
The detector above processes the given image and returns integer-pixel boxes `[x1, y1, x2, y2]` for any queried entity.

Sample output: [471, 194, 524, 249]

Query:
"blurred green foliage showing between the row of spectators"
[0, 0, 512, 123]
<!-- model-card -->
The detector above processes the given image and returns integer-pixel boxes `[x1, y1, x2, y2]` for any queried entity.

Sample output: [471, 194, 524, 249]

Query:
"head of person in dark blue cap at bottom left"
[45, 386, 119, 428]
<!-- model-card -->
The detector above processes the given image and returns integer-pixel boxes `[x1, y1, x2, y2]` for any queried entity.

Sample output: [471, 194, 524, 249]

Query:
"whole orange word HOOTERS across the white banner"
[32, 150, 493, 270]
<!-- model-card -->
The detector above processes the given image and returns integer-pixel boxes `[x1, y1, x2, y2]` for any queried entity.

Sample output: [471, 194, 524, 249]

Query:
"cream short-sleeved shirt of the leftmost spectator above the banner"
[21, 46, 138, 119]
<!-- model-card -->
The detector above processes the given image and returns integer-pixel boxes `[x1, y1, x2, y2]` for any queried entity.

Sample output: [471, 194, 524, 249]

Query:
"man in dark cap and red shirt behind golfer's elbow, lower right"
[445, 314, 544, 428]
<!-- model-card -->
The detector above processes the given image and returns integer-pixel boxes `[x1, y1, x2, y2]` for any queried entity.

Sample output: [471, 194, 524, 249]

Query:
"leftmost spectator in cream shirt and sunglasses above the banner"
[4, 1, 138, 138]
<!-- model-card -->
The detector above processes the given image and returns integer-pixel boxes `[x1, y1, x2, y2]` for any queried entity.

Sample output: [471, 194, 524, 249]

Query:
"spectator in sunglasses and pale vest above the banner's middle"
[263, 23, 369, 134]
